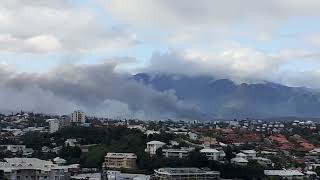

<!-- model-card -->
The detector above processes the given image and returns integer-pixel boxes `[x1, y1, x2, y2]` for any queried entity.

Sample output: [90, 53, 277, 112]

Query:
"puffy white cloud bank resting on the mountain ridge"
[141, 47, 320, 87]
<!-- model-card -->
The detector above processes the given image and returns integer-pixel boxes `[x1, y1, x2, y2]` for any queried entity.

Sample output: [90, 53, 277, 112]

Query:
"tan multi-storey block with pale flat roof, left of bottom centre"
[102, 153, 137, 169]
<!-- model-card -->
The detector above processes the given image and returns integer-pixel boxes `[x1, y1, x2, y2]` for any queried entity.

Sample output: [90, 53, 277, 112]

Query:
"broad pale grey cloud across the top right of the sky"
[101, 0, 320, 44]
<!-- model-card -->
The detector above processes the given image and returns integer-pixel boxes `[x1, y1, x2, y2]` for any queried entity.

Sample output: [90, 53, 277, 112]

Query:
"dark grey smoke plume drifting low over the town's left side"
[0, 63, 205, 119]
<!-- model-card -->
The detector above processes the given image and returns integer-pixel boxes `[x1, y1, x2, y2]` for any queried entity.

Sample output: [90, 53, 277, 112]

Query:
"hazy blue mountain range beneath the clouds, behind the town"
[134, 73, 320, 118]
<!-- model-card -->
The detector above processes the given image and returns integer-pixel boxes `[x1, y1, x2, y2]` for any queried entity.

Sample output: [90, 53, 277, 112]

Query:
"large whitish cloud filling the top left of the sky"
[0, 0, 137, 53]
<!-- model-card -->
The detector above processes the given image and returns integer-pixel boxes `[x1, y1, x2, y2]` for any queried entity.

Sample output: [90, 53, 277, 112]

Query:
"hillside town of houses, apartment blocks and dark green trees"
[0, 110, 320, 180]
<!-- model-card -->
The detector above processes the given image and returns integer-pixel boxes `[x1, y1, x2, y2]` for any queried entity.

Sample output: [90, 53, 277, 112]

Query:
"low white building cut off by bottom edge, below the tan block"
[102, 171, 150, 180]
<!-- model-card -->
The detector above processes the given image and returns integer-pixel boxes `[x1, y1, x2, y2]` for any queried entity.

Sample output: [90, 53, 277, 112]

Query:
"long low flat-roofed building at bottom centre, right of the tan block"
[154, 168, 220, 180]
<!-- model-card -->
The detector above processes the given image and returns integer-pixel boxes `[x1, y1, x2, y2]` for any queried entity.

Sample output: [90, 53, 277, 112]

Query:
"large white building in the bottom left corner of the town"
[0, 158, 70, 180]
